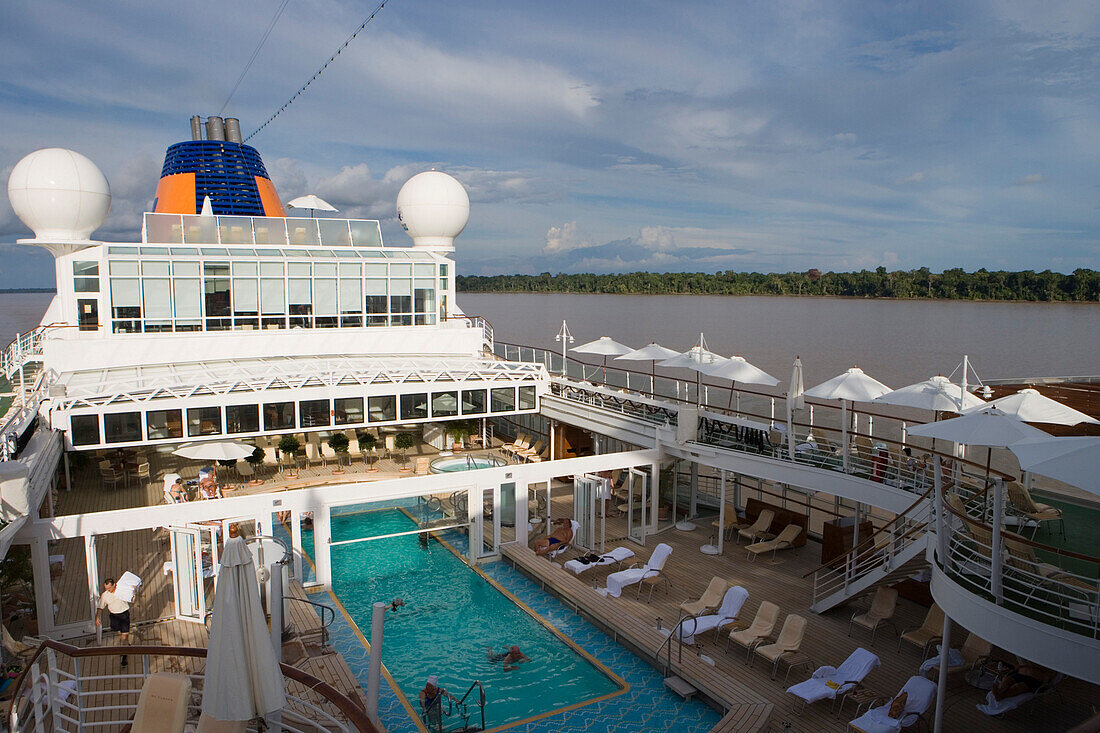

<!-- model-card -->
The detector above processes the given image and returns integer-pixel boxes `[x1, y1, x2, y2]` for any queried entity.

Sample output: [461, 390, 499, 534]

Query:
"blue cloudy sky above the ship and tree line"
[0, 0, 1100, 288]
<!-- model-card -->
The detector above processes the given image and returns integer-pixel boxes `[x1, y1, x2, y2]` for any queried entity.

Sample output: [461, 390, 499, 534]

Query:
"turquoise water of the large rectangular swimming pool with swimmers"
[331, 508, 628, 727]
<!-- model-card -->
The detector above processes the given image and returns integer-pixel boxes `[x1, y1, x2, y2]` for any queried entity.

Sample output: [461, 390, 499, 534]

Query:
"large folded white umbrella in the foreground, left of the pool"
[202, 537, 286, 721]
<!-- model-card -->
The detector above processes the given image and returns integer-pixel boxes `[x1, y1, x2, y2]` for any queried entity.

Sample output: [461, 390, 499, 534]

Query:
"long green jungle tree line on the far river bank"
[455, 267, 1100, 302]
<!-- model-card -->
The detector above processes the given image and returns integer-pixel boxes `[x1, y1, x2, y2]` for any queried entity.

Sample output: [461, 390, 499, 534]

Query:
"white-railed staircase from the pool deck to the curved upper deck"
[807, 490, 934, 613]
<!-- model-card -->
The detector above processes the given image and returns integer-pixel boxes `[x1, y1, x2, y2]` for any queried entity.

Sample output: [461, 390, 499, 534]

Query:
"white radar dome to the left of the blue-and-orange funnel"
[8, 147, 111, 242]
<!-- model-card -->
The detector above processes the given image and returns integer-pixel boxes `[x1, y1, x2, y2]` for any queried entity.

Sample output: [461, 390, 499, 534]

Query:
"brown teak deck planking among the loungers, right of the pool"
[506, 492, 1100, 733]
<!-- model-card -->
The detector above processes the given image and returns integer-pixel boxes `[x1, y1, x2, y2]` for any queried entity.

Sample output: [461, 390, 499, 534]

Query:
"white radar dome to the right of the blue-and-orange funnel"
[397, 171, 470, 247]
